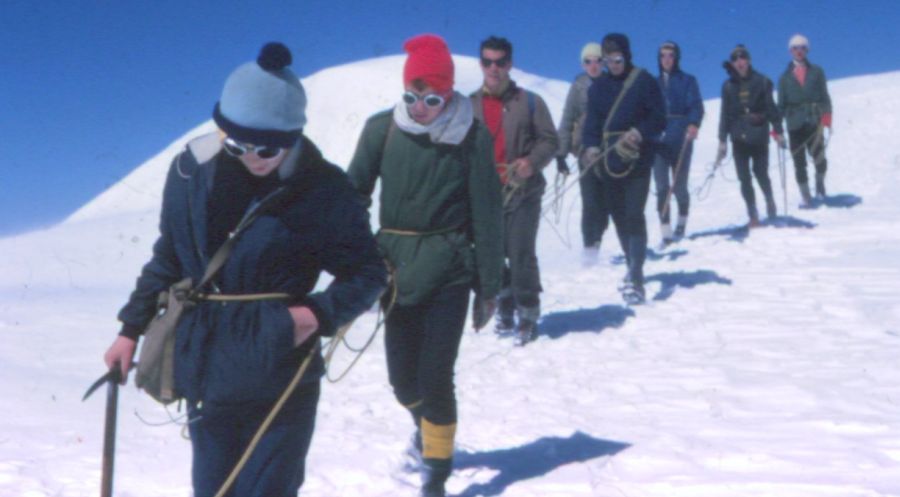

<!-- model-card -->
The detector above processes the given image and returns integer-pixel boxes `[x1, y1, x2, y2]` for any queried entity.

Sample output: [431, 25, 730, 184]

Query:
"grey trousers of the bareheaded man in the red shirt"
[500, 183, 544, 309]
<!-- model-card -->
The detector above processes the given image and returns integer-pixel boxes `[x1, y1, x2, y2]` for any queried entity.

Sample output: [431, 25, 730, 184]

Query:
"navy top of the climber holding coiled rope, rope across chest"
[583, 67, 666, 174]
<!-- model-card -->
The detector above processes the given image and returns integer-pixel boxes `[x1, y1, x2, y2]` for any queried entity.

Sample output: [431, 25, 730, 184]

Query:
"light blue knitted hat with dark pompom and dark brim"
[213, 42, 306, 148]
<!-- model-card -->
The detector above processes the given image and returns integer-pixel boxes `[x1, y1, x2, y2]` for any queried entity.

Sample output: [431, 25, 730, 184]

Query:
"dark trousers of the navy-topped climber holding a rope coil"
[603, 170, 650, 285]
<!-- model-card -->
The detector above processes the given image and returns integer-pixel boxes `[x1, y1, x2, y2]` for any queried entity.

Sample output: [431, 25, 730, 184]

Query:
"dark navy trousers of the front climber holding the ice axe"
[188, 382, 319, 497]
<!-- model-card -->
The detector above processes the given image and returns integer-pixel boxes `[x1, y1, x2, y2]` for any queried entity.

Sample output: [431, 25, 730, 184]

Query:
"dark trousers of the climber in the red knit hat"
[384, 285, 469, 425]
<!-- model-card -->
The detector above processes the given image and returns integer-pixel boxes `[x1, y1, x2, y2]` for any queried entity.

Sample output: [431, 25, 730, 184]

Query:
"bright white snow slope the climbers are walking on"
[0, 57, 900, 497]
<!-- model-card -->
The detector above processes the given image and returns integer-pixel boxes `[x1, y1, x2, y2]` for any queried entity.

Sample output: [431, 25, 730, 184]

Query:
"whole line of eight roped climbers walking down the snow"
[104, 33, 831, 497]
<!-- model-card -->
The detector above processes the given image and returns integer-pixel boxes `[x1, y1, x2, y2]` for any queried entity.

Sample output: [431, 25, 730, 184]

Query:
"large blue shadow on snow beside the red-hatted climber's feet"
[453, 431, 631, 497]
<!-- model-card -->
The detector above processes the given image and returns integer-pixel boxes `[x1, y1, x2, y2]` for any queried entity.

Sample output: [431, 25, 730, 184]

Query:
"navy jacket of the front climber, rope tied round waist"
[119, 135, 386, 406]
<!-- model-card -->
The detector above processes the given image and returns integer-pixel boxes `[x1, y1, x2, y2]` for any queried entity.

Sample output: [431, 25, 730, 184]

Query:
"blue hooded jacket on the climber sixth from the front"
[658, 69, 703, 157]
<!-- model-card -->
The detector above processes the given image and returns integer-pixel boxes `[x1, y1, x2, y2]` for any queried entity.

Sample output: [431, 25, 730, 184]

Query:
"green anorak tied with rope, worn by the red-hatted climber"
[348, 111, 503, 305]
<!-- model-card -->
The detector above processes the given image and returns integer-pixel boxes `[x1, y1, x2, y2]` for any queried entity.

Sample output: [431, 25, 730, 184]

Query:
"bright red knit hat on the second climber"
[403, 34, 453, 93]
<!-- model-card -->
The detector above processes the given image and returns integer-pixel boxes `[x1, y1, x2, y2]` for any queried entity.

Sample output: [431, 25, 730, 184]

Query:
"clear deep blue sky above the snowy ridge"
[0, 0, 900, 236]
